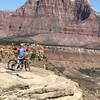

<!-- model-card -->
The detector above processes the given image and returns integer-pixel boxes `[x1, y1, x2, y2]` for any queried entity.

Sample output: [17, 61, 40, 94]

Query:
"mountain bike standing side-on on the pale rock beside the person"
[8, 59, 30, 71]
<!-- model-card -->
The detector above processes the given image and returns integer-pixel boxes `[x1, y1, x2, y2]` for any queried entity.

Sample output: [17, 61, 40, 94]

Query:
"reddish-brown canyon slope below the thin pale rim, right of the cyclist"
[45, 46, 100, 70]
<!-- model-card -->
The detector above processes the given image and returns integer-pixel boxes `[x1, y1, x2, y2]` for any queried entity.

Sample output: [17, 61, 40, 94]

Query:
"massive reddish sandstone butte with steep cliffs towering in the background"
[0, 0, 100, 45]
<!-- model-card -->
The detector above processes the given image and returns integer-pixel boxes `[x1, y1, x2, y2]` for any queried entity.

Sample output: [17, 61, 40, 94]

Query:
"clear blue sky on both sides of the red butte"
[0, 0, 100, 12]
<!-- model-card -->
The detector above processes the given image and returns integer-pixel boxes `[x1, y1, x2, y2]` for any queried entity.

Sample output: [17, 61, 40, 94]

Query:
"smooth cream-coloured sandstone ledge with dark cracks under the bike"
[0, 63, 83, 100]
